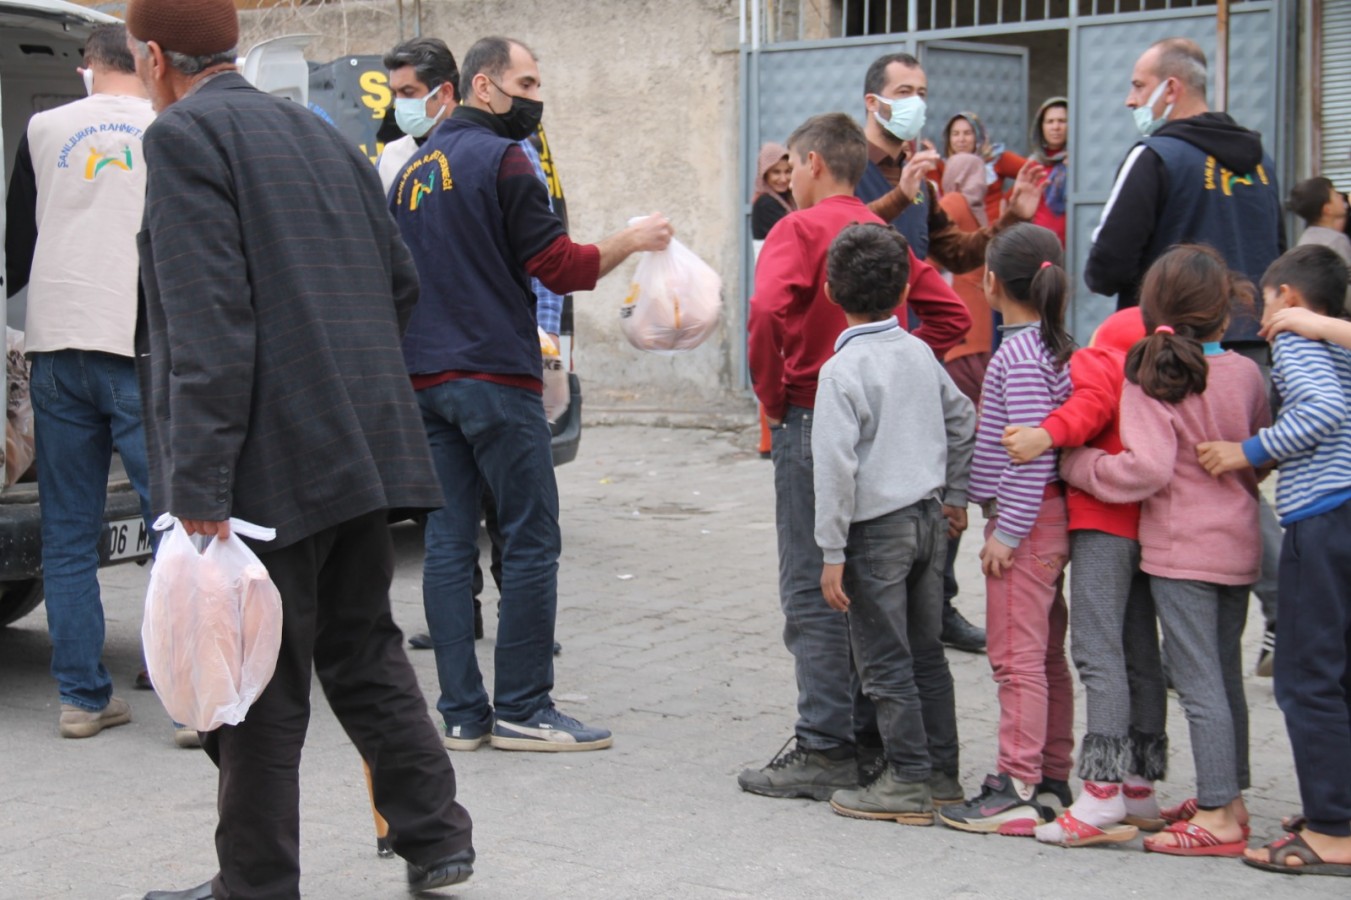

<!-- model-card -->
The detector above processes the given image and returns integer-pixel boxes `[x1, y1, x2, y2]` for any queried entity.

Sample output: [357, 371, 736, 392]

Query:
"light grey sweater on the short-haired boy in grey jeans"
[812, 316, 975, 564]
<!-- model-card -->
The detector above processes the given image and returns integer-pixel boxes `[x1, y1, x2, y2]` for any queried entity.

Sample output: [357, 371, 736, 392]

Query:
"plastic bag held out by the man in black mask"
[619, 229, 723, 353]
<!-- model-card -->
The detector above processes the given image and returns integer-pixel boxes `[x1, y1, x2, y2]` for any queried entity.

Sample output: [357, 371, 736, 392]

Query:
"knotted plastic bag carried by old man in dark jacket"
[141, 514, 281, 731]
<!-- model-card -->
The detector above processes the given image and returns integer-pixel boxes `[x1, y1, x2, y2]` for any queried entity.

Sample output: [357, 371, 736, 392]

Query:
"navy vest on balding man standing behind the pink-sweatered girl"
[1144, 136, 1281, 342]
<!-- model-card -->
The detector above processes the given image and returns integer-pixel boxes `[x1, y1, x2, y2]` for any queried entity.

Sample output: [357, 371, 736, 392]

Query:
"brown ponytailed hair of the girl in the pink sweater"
[1125, 243, 1252, 403]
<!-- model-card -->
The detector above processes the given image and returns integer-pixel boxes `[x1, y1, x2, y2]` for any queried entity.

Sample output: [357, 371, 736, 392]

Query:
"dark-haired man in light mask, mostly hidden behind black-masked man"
[376, 38, 459, 193]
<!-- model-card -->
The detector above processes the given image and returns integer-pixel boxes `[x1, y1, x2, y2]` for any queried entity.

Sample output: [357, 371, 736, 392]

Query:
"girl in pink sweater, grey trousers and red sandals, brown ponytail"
[1061, 245, 1271, 857]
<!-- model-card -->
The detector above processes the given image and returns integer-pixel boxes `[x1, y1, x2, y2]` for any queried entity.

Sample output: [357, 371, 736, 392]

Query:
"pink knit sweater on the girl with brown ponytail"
[1061, 351, 1271, 585]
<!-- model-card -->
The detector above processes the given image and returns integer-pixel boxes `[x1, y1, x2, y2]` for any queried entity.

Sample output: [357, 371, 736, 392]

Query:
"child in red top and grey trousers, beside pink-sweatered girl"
[1004, 307, 1167, 847]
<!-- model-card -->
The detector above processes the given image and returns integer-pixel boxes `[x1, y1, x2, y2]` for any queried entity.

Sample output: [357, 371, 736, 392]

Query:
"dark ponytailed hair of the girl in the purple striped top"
[985, 222, 1074, 368]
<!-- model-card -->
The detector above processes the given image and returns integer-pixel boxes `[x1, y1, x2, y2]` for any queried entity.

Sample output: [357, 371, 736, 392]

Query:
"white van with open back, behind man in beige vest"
[0, 0, 150, 628]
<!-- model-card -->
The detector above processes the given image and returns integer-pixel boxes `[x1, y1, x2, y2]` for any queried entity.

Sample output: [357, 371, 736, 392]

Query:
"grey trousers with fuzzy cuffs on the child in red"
[1070, 530, 1167, 781]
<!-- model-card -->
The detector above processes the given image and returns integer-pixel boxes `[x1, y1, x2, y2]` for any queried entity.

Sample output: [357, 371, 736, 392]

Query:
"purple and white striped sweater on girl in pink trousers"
[970, 323, 1070, 547]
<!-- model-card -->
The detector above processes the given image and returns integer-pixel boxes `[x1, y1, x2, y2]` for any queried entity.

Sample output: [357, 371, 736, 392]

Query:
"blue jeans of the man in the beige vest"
[31, 350, 150, 712]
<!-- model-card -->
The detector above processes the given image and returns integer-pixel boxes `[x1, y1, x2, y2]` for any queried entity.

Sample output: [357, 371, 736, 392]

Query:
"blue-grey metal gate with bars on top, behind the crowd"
[740, 0, 1296, 375]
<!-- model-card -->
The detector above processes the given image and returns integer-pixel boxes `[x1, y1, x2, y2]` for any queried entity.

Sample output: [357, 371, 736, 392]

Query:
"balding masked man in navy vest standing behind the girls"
[1084, 38, 1285, 329]
